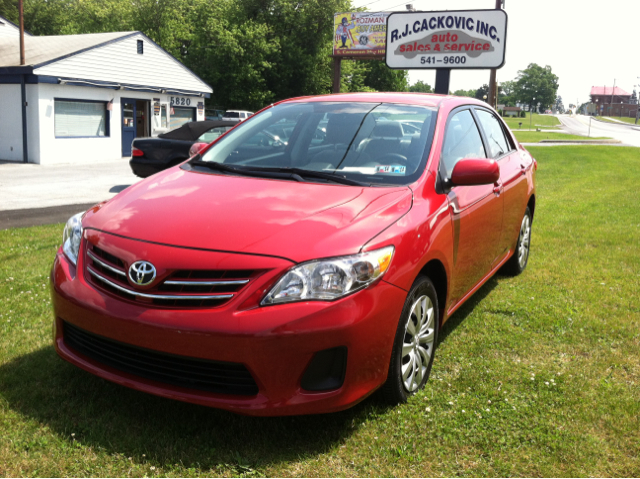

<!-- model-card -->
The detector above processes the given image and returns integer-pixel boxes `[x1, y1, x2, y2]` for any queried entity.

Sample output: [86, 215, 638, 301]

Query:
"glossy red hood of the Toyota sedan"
[83, 167, 412, 262]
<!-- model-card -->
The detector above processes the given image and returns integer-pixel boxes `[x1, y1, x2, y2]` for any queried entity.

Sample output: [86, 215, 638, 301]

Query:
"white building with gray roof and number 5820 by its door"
[0, 26, 212, 164]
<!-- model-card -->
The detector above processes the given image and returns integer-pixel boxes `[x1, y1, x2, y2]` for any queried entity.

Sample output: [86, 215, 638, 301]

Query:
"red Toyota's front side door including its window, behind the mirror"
[439, 107, 503, 307]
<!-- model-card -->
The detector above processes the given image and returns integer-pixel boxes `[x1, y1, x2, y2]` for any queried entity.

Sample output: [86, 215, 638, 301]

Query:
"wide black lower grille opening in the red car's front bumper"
[63, 321, 258, 396]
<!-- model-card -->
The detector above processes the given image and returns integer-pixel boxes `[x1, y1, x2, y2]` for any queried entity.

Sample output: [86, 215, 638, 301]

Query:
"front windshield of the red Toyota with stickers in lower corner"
[202, 102, 436, 185]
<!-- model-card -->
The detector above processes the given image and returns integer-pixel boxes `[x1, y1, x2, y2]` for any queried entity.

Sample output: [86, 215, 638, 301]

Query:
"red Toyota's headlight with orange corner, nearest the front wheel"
[260, 246, 394, 306]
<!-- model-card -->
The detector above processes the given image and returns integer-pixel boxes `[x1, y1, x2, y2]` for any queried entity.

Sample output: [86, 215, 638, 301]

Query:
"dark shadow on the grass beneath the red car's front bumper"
[0, 347, 384, 473]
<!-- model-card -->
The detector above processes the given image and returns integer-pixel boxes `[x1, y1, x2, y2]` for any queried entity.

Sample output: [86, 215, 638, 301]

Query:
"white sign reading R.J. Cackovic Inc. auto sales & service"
[385, 10, 507, 69]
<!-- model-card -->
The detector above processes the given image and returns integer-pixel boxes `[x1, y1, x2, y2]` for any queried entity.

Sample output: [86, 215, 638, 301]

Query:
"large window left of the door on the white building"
[54, 99, 109, 138]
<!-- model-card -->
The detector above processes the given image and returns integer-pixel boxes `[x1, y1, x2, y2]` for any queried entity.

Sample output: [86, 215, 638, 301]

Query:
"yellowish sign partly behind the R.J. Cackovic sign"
[333, 12, 389, 59]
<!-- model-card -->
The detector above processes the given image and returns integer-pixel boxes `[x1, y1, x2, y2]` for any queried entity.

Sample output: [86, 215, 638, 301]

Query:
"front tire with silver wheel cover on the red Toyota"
[382, 276, 440, 404]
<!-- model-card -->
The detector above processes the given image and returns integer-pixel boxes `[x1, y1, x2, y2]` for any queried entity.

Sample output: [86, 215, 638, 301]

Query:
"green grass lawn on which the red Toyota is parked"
[0, 146, 640, 477]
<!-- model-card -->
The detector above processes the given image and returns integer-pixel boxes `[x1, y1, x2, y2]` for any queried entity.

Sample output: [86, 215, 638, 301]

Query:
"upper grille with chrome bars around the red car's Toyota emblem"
[86, 245, 262, 308]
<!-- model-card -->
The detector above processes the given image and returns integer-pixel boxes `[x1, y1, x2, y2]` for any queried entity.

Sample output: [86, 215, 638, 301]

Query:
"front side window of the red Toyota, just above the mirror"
[440, 110, 487, 178]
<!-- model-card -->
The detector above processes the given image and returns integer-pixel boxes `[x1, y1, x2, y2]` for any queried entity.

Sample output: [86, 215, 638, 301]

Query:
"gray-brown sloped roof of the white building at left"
[0, 32, 132, 67]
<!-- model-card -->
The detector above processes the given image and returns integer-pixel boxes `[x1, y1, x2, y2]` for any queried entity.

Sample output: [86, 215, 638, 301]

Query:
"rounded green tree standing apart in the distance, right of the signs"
[514, 63, 558, 111]
